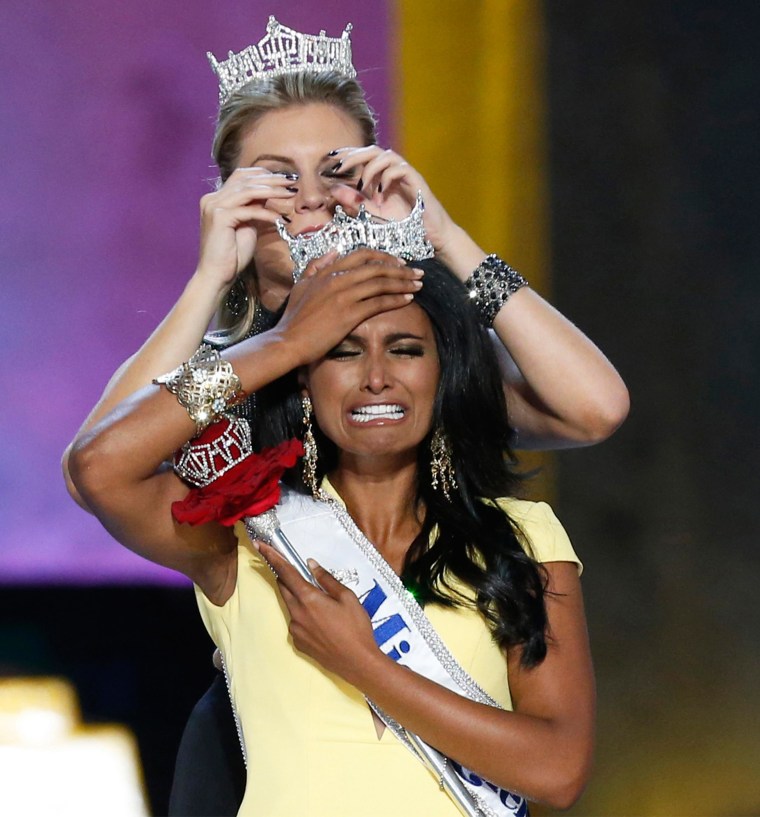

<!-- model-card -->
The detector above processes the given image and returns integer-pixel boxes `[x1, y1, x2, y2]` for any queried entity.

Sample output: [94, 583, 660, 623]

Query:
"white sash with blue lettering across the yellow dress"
[245, 486, 528, 817]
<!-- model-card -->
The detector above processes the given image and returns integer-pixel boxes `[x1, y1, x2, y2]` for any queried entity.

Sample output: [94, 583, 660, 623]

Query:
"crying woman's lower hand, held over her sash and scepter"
[259, 543, 378, 686]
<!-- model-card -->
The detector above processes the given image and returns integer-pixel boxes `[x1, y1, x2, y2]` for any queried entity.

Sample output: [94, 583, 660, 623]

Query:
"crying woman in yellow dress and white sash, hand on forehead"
[71, 262, 594, 816]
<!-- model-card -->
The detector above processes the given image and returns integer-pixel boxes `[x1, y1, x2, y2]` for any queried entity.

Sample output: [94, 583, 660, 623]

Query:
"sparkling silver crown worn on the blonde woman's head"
[206, 15, 356, 105]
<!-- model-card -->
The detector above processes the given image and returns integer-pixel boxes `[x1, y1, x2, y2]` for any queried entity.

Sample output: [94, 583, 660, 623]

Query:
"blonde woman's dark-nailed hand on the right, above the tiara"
[332, 145, 456, 254]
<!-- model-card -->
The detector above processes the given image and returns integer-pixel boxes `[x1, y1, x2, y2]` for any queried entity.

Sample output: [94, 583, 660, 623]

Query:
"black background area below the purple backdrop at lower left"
[0, 586, 209, 817]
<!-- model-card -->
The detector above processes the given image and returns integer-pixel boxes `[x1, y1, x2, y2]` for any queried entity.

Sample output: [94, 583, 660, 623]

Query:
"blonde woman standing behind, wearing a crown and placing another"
[63, 19, 616, 815]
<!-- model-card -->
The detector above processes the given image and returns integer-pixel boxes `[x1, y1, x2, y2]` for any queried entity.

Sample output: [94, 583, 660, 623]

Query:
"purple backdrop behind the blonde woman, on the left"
[0, 0, 390, 583]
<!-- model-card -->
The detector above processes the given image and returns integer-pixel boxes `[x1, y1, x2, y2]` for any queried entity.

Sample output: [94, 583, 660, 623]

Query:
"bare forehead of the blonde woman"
[240, 102, 364, 164]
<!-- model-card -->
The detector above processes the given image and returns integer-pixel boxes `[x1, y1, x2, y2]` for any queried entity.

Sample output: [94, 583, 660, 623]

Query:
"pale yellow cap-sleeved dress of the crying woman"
[196, 485, 580, 817]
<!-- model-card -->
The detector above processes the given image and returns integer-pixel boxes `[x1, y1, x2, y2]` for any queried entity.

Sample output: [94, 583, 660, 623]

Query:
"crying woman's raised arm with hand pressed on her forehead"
[69, 250, 420, 588]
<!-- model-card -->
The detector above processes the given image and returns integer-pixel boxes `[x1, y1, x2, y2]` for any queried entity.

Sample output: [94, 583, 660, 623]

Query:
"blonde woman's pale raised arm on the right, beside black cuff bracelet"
[336, 150, 629, 448]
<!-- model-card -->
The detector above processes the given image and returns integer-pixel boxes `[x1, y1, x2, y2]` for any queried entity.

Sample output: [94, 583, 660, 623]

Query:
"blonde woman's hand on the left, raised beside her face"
[198, 167, 295, 289]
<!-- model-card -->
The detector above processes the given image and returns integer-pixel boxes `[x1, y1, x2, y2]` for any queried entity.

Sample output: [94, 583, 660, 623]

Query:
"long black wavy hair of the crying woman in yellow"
[256, 259, 547, 667]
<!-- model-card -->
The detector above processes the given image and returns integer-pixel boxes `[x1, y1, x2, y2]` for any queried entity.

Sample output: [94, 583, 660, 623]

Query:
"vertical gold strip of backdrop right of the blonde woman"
[393, 0, 553, 498]
